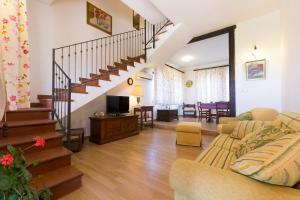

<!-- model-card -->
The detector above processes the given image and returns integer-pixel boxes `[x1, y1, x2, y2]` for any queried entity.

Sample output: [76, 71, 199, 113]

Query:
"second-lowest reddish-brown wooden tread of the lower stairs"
[25, 146, 72, 163]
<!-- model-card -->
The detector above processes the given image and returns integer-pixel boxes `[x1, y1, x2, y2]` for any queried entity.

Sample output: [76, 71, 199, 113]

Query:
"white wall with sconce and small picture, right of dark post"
[236, 10, 282, 113]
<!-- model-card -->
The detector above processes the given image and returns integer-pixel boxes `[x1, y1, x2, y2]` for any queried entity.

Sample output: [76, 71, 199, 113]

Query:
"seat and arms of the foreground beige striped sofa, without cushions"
[170, 110, 300, 200]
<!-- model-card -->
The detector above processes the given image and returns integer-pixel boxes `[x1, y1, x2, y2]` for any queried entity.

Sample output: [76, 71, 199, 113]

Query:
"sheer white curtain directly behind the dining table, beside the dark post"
[195, 67, 229, 103]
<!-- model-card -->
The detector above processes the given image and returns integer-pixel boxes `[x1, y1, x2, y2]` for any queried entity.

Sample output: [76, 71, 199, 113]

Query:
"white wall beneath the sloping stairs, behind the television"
[71, 76, 153, 135]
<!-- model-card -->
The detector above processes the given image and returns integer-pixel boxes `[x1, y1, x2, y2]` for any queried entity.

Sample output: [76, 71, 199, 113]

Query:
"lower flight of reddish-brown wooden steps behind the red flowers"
[0, 108, 82, 199]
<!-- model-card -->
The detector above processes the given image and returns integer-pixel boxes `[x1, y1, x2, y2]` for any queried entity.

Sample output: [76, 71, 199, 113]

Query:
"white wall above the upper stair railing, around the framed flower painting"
[27, 0, 133, 101]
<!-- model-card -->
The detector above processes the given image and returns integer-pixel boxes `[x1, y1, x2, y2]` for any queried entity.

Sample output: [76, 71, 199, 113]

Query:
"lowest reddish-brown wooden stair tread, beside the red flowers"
[32, 166, 83, 191]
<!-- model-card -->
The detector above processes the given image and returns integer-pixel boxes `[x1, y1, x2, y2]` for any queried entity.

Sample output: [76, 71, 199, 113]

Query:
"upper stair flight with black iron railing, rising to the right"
[38, 19, 173, 139]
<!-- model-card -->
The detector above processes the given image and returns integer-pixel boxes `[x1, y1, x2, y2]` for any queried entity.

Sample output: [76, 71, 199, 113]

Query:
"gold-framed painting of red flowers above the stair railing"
[87, 2, 112, 35]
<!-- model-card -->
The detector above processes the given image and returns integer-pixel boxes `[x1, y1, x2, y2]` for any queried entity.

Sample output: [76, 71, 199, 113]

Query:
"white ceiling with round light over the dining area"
[167, 34, 229, 69]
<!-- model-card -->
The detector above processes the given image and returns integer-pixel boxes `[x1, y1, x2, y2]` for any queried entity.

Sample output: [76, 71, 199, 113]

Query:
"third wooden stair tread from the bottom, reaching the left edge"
[0, 132, 63, 146]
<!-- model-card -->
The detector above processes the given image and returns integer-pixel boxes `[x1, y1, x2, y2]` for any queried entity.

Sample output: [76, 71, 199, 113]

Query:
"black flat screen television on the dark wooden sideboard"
[106, 96, 129, 114]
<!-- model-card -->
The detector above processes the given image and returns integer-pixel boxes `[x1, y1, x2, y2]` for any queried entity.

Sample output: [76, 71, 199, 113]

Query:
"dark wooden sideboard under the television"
[90, 115, 139, 144]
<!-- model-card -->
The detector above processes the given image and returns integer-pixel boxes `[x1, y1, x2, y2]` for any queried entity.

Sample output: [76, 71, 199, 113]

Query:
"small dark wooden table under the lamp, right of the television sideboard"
[134, 106, 154, 130]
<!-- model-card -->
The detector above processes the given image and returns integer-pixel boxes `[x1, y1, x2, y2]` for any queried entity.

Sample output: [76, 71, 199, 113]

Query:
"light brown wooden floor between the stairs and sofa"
[62, 129, 214, 200]
